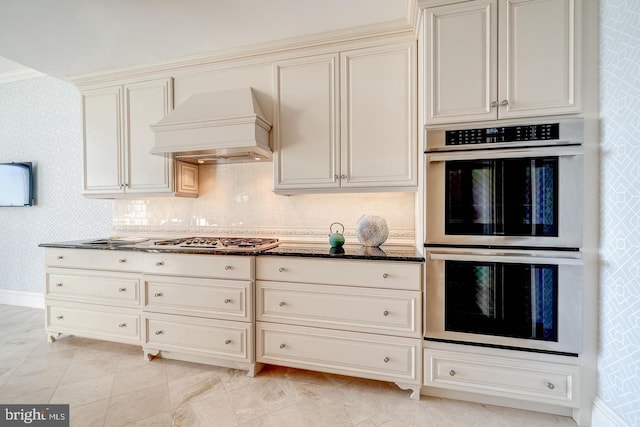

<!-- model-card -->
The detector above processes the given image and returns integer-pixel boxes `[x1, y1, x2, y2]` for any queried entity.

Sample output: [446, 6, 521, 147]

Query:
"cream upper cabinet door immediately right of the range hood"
[273, 54, 340, 193]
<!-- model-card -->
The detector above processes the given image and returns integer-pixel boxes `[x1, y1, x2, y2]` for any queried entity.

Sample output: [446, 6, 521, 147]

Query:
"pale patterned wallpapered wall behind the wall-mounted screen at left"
[0, 77, 113, 294]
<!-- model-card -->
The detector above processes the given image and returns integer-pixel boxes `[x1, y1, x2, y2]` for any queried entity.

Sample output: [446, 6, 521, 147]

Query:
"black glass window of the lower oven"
[445, 261, 558, 341]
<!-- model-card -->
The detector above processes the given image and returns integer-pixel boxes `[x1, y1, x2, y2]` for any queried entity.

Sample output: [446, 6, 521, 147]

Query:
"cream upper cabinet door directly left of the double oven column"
[340, 43, 418, 189]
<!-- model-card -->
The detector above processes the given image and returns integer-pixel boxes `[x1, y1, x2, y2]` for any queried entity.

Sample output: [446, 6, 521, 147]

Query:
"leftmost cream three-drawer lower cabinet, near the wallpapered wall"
[45, 248, 142, 345]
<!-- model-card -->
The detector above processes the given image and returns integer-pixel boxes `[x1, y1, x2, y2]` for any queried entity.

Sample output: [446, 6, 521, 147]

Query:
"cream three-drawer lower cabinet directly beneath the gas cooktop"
[142, 253, 260, 376]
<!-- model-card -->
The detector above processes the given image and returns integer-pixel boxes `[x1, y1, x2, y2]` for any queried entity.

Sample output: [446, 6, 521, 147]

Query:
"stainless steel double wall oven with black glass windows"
[425, 119, 584, 354]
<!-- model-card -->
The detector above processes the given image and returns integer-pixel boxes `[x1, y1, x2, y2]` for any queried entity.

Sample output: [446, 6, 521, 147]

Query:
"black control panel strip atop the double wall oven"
[445, 123, 560, 145]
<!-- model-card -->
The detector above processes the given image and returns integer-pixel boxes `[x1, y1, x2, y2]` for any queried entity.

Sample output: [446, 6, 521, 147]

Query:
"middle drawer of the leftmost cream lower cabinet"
[46, 268, 140, 307]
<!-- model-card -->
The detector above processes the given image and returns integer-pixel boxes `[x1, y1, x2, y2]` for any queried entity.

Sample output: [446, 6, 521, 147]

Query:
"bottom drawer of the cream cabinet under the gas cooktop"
[143, 312, 253, 362]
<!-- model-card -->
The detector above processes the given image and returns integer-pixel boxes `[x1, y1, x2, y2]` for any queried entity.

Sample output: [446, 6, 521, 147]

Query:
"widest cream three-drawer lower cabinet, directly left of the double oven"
[256, 256, 422, 399]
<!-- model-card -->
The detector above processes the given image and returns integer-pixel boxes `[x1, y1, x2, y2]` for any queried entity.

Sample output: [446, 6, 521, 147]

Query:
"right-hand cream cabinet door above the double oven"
[498, 0, 580, 118]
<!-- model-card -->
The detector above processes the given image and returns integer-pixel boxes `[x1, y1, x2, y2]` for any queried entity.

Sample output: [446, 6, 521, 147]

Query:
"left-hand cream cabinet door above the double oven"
[423, 0, 498, 124]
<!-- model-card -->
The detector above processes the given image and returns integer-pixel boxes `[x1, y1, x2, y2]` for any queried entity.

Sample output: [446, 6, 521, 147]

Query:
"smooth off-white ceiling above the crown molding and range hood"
[0, 0, 414, 79]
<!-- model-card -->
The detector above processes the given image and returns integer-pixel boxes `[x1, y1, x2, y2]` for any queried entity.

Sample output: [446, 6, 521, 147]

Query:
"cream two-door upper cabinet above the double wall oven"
[422, 0, 581, 124]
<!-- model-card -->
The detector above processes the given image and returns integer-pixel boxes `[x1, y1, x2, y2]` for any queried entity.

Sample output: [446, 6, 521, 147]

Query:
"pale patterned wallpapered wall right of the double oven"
[598, 0, 640, 426]
